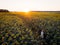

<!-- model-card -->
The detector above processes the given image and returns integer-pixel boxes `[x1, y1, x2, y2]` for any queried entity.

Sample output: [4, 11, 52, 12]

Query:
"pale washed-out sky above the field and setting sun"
[0, 0, 60, 11]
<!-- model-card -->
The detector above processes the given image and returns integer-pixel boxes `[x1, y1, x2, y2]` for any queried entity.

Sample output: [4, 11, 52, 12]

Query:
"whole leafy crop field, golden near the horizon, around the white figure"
[0, 12, 60, 45]
